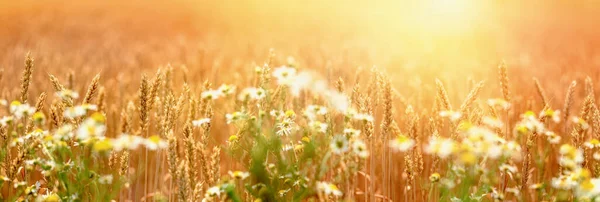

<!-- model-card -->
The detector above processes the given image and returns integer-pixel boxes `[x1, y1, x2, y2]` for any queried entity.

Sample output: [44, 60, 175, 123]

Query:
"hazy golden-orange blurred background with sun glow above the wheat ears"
[0, 0, 600, 104]
